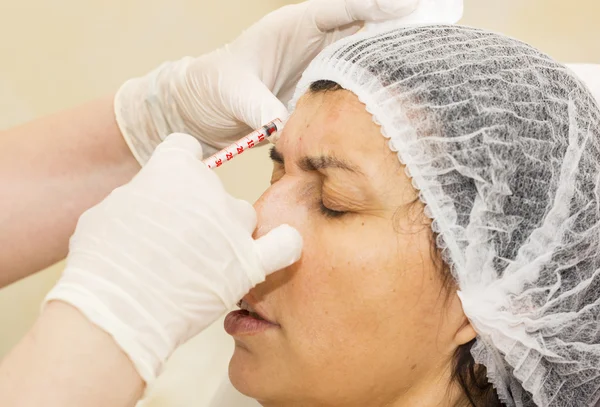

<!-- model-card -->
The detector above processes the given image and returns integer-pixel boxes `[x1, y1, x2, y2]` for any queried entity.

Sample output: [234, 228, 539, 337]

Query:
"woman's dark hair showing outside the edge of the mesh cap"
[310, 80, 504, 407]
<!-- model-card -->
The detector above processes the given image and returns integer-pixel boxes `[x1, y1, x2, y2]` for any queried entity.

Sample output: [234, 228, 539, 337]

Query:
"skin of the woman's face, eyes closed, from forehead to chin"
[229, 90, 475, 407]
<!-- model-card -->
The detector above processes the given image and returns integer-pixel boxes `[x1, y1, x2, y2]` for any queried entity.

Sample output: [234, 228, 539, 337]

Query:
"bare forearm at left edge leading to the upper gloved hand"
[0, 97, 140, 288]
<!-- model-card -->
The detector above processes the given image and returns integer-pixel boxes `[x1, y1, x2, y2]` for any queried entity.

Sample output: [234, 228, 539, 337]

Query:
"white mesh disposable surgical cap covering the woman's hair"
[290, 26, 600, 407]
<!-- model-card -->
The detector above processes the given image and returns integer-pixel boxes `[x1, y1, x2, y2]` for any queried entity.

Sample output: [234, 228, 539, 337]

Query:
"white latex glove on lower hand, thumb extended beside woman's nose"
[46, 134, 302, 382]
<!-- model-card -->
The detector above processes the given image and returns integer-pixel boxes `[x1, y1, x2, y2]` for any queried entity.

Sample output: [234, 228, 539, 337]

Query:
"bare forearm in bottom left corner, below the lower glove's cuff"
[0, 301, 144, 407]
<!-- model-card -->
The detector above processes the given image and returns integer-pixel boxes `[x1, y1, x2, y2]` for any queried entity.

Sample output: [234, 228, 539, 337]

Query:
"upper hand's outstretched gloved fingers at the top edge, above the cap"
[309, 0, 419, 32]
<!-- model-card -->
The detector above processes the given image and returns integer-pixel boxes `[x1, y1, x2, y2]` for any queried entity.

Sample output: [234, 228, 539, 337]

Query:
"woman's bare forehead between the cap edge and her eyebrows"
[277, 90, 389, 158]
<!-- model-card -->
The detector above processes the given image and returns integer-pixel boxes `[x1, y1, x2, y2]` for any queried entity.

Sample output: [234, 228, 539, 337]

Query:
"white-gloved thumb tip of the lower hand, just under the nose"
[255, 225, 303, 282]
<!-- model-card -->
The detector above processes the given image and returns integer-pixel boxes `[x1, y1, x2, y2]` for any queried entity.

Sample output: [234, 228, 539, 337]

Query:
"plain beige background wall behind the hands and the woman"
[0, 0, 600, 407]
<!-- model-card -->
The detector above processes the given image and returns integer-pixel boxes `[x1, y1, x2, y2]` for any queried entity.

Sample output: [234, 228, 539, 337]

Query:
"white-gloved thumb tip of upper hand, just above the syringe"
[232, 77, 289, 129]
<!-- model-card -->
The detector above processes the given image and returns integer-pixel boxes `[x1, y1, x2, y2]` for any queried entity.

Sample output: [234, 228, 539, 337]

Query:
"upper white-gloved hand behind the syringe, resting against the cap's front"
[115, 0, 419, 165]
